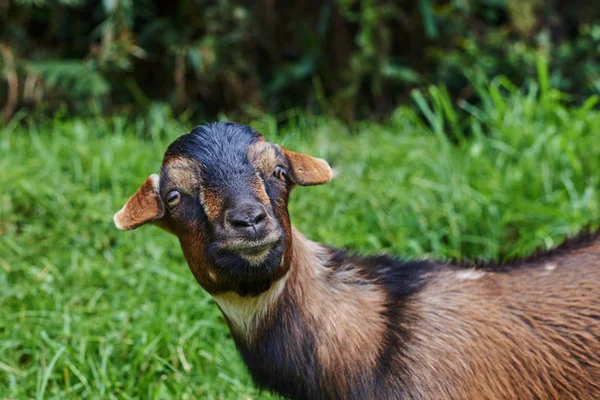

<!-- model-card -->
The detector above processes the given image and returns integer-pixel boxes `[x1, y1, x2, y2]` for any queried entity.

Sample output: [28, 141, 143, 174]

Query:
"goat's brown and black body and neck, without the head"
[224, 232, 600, 399]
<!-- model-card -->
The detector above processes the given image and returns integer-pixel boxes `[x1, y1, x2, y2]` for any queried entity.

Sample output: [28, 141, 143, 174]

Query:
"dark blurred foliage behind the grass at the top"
[0, 0, 600, 121]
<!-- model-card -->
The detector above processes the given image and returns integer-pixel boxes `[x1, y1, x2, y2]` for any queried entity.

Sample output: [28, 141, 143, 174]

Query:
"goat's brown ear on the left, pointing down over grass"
[113, 174, 165, 231]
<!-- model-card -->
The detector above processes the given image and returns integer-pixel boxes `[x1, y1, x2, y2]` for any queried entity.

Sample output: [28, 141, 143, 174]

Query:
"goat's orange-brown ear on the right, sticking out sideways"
[282, 147, 333, 186]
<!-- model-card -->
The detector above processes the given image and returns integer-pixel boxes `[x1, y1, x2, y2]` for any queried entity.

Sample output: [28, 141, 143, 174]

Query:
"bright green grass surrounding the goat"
[0, 79, 600, 399]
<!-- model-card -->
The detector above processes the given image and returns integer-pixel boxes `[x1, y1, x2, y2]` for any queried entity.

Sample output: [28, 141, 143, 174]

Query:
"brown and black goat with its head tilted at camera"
[114, 122, 600, 400]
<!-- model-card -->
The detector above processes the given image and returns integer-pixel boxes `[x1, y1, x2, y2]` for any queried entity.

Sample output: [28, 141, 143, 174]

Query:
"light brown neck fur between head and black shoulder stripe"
[288, 229, 386, 396]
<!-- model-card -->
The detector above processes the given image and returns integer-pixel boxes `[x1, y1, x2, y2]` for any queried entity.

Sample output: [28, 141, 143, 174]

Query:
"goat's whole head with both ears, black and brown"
[114, 122, 332, 295]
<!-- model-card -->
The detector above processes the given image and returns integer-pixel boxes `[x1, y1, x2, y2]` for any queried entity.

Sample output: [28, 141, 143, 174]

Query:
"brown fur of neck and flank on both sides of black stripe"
[250, 230, 600, 400]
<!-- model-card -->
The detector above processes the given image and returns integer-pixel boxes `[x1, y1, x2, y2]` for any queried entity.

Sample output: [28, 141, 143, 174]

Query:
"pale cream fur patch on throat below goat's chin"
[214, 276, 287, 339]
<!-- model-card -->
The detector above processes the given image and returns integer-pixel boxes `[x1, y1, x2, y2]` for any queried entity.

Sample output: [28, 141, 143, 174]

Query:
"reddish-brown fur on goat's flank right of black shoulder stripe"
[399, 248, 600, 399]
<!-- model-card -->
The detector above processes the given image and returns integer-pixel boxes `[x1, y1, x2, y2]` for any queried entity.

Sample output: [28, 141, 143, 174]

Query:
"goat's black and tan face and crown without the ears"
[161, 122, 290, 295]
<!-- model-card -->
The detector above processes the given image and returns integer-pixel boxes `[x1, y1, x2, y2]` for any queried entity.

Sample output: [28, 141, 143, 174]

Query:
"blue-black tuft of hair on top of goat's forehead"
[165, 122, 264, 167]
